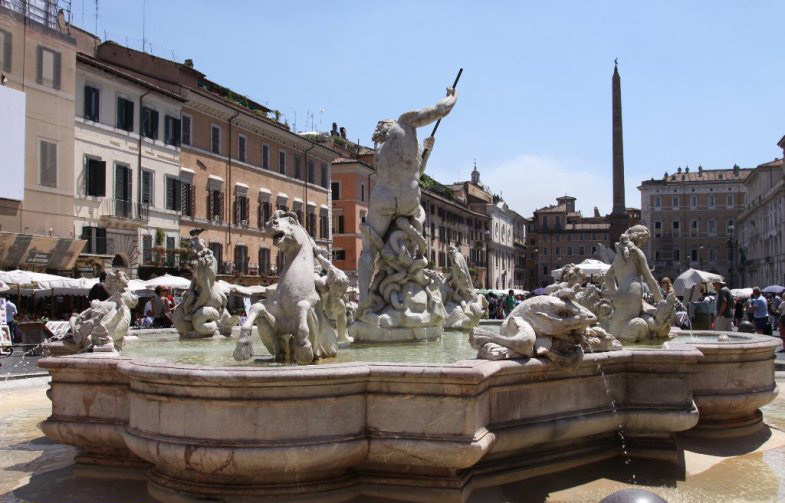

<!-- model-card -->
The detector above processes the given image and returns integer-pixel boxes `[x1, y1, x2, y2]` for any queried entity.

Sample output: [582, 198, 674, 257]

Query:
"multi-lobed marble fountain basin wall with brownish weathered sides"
[38, 332, 779, 502]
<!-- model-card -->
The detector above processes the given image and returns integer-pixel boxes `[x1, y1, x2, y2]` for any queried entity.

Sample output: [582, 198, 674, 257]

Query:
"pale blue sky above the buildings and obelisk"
[78, 0, 785, 216]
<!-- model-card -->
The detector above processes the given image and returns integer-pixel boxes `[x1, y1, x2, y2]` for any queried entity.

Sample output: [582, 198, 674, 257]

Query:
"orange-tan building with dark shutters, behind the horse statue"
[90, 42, 337, 284]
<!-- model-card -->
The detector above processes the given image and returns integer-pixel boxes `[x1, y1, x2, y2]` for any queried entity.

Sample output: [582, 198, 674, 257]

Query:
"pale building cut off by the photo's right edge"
[740, 154, 785, 288]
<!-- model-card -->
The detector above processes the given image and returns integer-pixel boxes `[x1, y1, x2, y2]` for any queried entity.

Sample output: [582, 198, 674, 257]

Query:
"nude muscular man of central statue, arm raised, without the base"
[358, 87, 455, 305]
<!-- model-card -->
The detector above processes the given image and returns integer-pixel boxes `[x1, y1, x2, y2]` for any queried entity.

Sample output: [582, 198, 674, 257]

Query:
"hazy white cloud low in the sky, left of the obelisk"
[480, 154, 624, 217]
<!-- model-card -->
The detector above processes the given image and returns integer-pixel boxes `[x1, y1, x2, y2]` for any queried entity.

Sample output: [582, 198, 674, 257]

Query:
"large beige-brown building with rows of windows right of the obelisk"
[638, 166, 752, 287]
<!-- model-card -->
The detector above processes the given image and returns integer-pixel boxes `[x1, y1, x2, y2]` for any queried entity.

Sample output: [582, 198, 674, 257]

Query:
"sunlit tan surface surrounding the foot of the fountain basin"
[0, 372, 785, 503]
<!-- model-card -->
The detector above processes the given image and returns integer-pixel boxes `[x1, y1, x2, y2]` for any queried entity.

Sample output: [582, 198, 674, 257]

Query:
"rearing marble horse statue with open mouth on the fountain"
[234, 210, 336, 364]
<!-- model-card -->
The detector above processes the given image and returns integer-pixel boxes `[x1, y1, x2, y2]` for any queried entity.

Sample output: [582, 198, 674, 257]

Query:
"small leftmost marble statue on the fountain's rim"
[57, 271, 139, 353]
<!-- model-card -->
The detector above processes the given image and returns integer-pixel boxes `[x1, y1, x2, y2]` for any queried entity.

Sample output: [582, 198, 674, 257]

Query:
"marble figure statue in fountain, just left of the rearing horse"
[172, 229, 238, 339]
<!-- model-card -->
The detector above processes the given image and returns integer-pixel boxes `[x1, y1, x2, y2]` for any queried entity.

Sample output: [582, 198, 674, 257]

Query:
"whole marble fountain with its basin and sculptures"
[32, 86, 778, 502]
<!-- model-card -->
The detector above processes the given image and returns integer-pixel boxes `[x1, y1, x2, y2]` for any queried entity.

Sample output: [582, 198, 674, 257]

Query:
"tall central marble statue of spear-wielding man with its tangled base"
[349, 88, 455, 341]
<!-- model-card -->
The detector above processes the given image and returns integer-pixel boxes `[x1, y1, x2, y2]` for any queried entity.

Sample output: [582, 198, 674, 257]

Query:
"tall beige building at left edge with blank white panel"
[0, 1, 84, 271]
